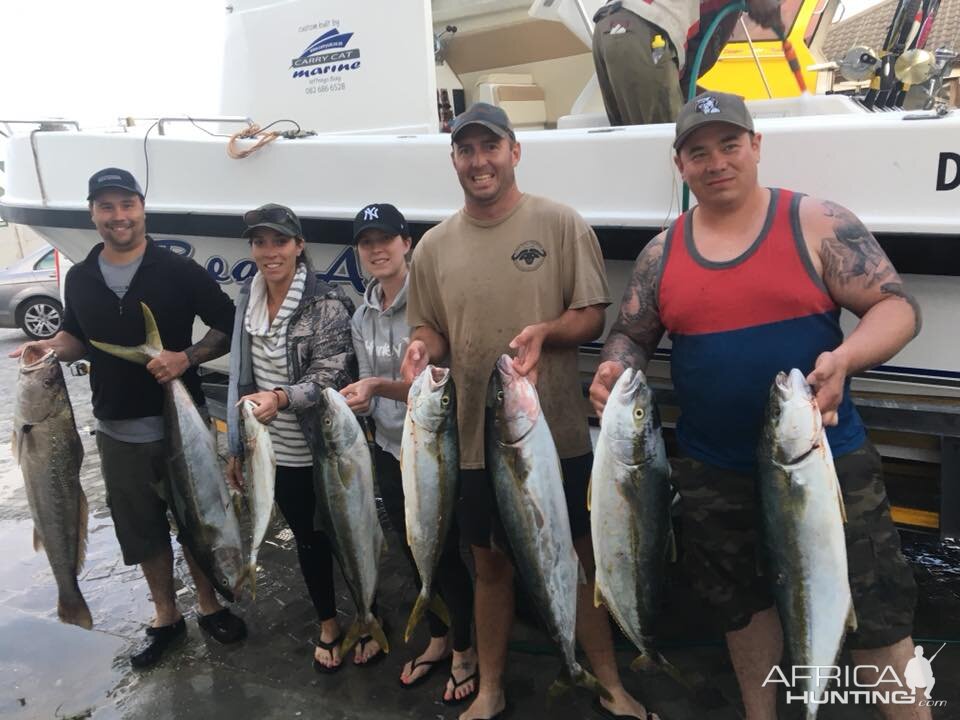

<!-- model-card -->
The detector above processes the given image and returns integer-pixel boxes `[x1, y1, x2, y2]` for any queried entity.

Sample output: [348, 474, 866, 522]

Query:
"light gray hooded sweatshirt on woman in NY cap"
[351, 275, 410, 458]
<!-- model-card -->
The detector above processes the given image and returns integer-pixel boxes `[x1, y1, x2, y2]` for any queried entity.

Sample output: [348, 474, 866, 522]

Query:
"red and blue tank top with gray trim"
[657, 189, 866, 472]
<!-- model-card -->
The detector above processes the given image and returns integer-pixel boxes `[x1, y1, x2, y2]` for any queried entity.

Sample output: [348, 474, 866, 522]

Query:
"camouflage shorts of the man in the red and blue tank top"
[672, 442, 917, 649]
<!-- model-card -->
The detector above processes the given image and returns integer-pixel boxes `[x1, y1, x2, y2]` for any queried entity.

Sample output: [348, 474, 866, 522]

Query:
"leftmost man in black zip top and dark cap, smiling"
[12, 168, 246, 668]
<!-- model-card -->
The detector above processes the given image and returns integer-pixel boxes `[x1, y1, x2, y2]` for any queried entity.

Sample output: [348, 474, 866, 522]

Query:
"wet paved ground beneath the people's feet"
[0, 331, 960, 720]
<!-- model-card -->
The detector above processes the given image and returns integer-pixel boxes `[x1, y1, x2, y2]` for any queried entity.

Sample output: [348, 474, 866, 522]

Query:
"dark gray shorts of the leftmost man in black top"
[97, 432, 170, 565]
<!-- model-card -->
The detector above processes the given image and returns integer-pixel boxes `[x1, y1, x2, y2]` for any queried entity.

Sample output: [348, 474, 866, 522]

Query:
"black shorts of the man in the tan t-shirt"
[457, 453, 593, 549]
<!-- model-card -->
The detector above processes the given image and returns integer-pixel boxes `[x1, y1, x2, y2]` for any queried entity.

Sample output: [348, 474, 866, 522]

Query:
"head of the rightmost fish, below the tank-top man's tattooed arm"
[763, 368, 823, 465]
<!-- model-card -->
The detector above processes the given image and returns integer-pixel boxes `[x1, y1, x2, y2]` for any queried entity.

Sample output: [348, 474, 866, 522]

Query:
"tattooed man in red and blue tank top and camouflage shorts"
[590, 92, 930, 720]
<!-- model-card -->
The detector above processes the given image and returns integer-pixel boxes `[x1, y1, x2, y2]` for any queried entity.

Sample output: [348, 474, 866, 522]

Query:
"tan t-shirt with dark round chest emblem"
[407, 195, 610, 468]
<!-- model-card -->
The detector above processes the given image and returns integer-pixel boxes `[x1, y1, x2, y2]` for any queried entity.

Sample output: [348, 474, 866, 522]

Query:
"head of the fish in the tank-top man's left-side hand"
[600, 368, 663, 465]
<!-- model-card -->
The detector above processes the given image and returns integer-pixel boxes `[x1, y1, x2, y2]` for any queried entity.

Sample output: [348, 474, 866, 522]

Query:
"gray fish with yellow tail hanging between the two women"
[313, 388, 390, 655]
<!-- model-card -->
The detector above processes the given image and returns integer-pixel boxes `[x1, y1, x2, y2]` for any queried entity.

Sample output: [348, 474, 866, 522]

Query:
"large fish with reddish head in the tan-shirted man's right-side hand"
[486, 355, 610, 699]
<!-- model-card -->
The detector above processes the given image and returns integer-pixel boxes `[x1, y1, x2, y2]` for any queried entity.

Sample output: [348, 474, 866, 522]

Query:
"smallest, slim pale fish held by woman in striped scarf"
[240, 400, 277, 596]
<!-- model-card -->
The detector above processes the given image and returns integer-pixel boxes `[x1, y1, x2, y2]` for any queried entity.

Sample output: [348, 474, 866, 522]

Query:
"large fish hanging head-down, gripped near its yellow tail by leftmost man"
[90, 303, 246, 601]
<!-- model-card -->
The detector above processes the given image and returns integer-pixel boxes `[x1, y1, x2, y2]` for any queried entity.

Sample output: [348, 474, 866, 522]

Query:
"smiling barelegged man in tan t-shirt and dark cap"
[402, 103, 648, 720]
